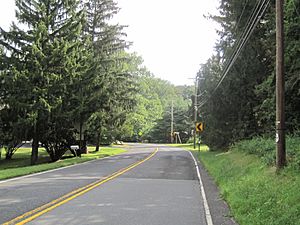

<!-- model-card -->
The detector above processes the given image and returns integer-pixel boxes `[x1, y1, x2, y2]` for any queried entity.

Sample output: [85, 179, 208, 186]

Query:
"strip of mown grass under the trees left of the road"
[0, 147, 125, 180]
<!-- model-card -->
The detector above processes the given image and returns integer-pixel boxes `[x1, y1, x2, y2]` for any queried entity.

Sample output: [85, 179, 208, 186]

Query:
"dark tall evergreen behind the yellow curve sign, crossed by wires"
[200, 0, 273, 147]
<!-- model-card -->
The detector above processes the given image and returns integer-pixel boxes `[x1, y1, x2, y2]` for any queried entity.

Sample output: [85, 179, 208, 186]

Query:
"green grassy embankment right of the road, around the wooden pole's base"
[172, 137, 300, 225]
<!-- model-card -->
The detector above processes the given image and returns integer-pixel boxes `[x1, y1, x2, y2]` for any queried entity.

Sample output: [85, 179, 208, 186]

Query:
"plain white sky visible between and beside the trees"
[0, 0, 219, 85]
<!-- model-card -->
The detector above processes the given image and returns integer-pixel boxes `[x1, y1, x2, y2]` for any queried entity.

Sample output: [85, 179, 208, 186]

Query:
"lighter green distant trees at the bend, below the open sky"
[121, 55, 192, 142]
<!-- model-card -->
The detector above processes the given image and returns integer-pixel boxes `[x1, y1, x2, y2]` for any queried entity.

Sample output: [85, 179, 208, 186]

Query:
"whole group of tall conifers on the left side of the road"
[0, 0, 136, 164]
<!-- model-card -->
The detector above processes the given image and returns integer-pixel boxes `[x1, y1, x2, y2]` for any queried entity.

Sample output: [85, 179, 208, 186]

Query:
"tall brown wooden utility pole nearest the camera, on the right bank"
[276, 0, 286, 170]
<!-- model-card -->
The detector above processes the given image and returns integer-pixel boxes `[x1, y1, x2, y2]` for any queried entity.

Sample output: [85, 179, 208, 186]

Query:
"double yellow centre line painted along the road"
[2, 148, 158, 225]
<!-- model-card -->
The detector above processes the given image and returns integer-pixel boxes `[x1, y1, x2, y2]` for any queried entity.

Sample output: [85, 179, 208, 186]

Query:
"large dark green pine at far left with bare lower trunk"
[1, 0, 84, 164]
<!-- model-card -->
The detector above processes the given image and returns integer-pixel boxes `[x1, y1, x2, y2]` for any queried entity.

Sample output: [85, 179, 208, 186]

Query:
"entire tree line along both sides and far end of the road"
[4, 0, 300, 164]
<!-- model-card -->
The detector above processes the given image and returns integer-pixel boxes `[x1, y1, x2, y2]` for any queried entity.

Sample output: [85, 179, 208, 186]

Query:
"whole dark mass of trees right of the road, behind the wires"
[198, 0, 300, 148]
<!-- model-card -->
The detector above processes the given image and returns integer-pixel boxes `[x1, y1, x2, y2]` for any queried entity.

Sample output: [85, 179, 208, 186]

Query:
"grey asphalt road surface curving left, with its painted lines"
[0, 144, 239, 225]
